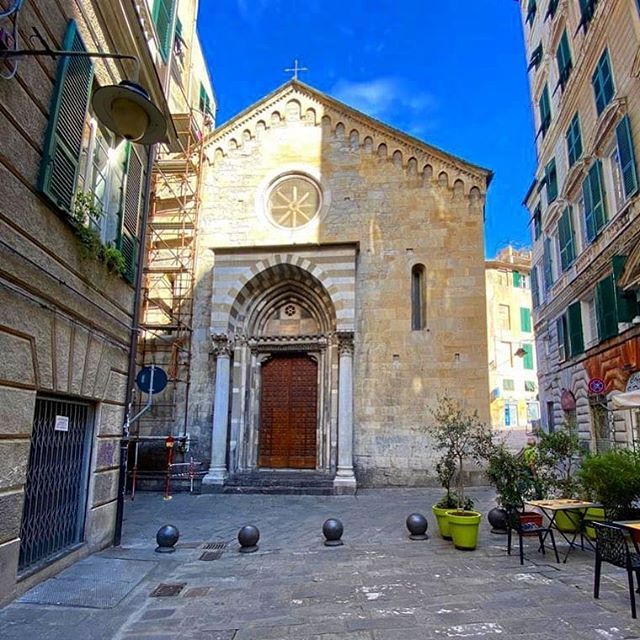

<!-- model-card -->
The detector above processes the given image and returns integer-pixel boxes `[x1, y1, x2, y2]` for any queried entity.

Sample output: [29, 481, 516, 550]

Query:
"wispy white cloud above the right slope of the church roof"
[329, 77, 437, 136]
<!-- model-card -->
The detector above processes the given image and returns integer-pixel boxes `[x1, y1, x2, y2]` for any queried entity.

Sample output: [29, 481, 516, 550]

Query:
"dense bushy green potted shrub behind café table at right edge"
[578, 449, 640, 542]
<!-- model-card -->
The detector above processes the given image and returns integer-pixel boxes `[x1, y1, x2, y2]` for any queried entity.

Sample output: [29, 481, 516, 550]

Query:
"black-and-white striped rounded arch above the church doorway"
[216, 254, 354, 334]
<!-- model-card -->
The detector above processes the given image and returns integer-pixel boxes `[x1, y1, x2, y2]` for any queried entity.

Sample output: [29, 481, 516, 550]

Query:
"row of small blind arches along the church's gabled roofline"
[206, 82, 488, 199]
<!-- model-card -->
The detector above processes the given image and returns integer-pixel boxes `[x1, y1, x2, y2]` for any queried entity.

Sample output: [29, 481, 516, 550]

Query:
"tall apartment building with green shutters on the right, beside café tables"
[521, 0, 640, 451]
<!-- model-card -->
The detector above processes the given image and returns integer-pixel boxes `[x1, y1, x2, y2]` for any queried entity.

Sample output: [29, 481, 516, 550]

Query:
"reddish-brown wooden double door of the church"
[258, 354, 318, 469]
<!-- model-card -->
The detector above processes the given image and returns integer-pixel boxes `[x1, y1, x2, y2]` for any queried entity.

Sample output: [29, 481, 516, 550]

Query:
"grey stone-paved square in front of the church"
[0, 489, 640, 640]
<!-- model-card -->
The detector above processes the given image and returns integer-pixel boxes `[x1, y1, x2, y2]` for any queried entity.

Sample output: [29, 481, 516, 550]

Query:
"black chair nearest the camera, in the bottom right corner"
[591, 522, 640, 618]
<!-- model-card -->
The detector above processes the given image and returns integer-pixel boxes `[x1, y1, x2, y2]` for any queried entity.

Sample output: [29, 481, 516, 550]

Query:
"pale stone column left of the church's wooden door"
[202, 334, 232, 489]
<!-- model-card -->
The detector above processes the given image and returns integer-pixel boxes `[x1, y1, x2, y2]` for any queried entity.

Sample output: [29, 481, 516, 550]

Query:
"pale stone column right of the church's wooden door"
[333, 331, 356, 494]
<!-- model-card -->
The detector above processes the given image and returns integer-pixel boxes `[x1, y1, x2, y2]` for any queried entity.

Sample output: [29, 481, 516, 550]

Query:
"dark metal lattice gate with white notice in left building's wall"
[18, 397, 93, 571]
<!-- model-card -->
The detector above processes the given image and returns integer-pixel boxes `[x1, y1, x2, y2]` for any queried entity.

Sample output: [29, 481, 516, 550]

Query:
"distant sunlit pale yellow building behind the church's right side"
[485, 246, 540, 449]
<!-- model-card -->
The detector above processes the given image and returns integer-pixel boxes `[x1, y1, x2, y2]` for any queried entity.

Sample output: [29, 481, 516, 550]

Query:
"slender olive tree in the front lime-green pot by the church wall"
[430, 395, 493, 550]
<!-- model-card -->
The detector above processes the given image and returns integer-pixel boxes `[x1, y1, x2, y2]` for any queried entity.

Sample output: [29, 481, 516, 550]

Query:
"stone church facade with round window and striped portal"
[189, 80, 491, 493]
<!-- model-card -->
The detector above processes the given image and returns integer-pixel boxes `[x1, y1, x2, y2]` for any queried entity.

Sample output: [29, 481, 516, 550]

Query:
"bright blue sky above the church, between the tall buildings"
[199, 0, 535, 256]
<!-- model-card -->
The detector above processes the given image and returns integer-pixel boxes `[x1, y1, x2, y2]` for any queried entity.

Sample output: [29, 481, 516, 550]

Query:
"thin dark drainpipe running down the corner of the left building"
[113, 145, 156, 547]
